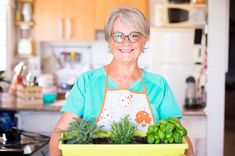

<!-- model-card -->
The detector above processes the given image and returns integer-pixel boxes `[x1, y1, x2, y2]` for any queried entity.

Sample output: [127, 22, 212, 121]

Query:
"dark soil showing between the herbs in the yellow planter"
[93, 136, 147, 144]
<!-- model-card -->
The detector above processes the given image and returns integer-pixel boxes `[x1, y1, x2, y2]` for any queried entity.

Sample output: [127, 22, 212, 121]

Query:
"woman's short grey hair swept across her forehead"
[104, 7, 150, 41]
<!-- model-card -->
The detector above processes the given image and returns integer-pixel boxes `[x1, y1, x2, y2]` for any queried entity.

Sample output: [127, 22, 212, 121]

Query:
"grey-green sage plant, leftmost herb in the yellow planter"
[59, 118, 98, 144]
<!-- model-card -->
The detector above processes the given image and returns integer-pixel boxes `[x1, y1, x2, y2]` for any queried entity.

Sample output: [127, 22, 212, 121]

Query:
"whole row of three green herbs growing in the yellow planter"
[59, 115, 187, 144]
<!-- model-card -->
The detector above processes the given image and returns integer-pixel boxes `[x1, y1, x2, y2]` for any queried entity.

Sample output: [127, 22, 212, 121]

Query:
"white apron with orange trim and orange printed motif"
[96, 67, 155, 131]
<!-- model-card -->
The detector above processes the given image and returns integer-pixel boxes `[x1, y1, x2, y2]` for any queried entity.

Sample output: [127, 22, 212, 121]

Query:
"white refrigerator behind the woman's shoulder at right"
[148, 27, 195, 108]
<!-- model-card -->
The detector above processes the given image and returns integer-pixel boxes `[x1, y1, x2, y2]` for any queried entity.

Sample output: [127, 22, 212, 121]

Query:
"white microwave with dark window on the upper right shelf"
[154, 3, 207, 27]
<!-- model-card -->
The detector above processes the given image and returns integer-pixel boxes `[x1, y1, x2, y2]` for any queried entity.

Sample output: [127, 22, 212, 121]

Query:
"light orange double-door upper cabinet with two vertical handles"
[34, 0, 95, 41]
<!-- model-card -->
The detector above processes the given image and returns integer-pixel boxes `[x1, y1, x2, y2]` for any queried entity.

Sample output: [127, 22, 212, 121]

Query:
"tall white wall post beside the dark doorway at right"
[207, 0, 229, 156]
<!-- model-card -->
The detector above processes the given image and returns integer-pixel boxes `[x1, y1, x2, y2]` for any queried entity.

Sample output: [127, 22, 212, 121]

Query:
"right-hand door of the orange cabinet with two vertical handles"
[64, 0, 95, 40]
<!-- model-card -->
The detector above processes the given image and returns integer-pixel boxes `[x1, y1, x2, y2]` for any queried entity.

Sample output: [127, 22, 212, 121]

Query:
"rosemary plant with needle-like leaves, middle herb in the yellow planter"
[110, 115, 137, 144]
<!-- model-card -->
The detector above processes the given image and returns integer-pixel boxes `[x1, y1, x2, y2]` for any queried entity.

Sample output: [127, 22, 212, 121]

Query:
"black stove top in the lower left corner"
[0, 128, 49, 156]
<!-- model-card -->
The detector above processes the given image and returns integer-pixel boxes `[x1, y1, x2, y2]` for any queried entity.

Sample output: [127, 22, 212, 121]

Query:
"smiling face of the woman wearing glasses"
[109, 18, 147, 64]
